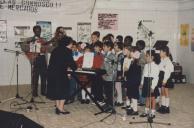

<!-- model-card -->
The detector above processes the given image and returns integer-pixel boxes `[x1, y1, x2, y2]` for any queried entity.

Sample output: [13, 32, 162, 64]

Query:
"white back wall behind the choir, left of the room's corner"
[0, 0, 178, 85]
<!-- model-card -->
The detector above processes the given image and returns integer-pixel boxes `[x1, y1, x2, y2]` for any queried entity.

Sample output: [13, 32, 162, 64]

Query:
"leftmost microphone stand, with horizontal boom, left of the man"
[0, 49, 25, 103]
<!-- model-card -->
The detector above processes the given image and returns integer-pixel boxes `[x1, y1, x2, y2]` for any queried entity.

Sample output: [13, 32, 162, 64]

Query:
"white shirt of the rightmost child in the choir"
[159, 57, 174, 83]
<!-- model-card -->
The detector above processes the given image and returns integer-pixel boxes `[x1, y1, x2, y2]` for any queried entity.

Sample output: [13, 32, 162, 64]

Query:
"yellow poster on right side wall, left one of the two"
[180, 24, 189, 46]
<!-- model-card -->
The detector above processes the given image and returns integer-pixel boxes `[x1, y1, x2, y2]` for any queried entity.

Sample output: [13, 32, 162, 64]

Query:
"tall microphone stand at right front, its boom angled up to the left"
[129, 21, 171, 128]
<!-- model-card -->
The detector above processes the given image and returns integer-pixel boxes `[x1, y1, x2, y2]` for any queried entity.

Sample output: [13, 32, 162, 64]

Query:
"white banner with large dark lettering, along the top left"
[0, 0, 94, 15]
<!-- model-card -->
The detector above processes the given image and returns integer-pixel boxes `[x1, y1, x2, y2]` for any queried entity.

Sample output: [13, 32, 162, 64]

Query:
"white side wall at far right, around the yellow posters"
[177, 2, 194, 83]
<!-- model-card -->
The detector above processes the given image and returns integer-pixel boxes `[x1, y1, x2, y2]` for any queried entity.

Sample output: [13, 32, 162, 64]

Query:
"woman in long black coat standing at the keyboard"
[47, 36, 77, 114]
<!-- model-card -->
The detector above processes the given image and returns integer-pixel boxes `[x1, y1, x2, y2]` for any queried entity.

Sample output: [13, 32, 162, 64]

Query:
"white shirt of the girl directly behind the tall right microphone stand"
[141, 62, 160, 90]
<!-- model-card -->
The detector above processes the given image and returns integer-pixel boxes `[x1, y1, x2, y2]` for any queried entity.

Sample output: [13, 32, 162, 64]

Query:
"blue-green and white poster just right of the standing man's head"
[36, 21, 52, 41]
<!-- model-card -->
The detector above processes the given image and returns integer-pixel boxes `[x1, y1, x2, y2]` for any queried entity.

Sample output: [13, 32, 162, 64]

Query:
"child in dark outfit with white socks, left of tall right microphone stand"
[126, 47, 141, 115]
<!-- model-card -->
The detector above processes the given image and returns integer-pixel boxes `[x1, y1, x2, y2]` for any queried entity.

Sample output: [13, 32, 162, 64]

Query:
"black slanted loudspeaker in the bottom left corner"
[0, 110, 44, 128]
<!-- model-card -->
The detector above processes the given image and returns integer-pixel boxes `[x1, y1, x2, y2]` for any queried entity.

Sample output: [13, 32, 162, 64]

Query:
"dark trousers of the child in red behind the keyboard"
[92, 76, 104, 101]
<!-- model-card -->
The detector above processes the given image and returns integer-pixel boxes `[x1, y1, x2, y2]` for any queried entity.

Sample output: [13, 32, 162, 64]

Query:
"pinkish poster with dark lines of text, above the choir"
[98, 13, 118, 30]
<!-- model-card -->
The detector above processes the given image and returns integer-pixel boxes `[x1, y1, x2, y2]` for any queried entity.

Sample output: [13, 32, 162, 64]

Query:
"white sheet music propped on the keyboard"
[82, 52, 94, 68]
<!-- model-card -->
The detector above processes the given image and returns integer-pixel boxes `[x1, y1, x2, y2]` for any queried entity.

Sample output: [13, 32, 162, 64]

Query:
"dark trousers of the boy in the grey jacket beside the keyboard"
[103, 81, 113, 106]
